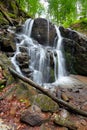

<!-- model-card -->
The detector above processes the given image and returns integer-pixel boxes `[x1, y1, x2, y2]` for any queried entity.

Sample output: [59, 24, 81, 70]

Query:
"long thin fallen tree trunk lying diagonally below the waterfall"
[9, 68, 87, 117]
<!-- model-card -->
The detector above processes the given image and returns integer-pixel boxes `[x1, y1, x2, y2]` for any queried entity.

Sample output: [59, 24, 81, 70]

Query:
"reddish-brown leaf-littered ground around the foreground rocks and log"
[0, 75, 87, 130]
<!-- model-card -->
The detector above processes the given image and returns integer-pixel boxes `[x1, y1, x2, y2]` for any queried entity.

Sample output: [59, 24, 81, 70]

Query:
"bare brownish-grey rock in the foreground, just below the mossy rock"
[20, 105, 46, 126]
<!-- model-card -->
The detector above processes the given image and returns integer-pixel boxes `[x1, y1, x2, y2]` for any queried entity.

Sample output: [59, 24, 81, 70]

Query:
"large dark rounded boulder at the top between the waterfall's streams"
[31, 18, 56, 46]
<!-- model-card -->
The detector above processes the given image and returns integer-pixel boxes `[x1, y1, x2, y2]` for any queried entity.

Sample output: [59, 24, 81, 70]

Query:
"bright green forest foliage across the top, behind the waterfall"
[16, 0, 87, 27]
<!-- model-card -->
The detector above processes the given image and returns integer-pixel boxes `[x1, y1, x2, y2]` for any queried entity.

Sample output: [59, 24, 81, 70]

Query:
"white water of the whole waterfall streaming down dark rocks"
[11, 19, 67, 85]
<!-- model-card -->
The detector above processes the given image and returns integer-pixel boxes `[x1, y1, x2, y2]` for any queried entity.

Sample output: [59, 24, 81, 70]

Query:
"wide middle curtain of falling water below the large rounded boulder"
[29, 45, 50, 84]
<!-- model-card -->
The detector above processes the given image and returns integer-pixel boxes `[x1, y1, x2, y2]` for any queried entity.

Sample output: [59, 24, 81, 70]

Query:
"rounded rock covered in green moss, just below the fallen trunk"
[30, 94, 59, 112]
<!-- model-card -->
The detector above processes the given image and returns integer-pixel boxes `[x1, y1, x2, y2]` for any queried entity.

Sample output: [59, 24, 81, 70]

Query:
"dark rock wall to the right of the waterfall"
[60, 27, 87, 76]
